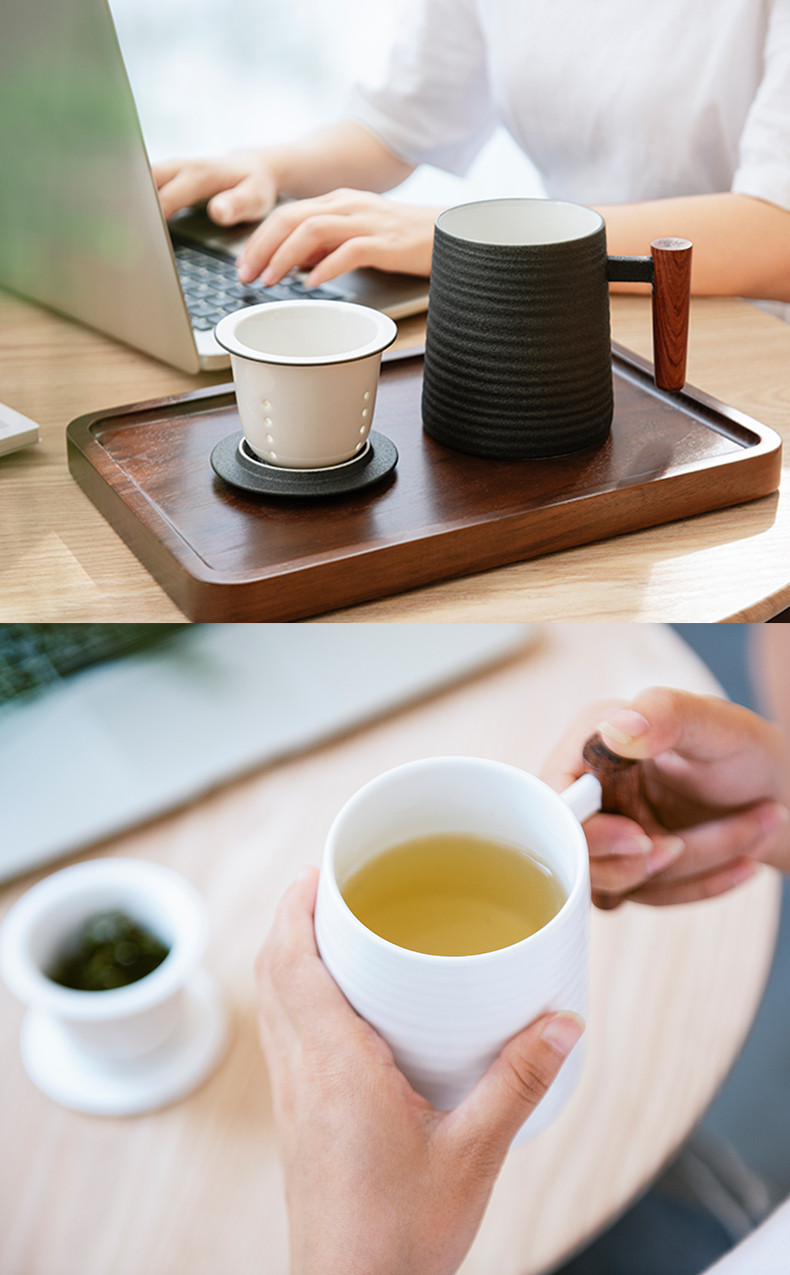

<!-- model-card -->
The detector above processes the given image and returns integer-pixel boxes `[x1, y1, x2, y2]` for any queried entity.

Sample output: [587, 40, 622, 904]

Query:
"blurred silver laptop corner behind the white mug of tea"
[0, 623, 536, 881]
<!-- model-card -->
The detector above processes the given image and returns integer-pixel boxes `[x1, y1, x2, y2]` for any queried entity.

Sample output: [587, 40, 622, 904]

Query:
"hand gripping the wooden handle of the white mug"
[543, 687, 790, 908]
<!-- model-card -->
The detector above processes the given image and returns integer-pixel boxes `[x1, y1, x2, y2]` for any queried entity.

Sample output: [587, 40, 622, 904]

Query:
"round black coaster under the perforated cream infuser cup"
[212, 430, 398, 497]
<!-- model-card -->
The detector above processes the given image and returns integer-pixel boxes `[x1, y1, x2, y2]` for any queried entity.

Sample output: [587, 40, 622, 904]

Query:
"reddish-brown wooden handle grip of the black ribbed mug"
[650, 238, 692, 391]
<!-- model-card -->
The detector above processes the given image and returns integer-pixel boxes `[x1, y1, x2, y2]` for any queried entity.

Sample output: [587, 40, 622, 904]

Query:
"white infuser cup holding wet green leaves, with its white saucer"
[0, 858, 227, 1116]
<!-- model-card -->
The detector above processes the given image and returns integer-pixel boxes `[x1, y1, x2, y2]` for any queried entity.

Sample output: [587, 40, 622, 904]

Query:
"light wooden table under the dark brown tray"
[0, 296, 790, 621]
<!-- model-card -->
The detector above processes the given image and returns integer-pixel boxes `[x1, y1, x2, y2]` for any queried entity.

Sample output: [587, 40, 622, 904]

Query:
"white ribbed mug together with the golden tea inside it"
[315, 756, 600, 1141]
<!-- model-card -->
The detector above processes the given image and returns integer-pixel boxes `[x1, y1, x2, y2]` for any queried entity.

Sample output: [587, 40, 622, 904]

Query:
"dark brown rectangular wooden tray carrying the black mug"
[68, 346, 781, 621]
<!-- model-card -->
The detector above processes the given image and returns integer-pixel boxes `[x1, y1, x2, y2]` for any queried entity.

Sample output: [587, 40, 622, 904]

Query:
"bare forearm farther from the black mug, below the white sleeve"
[264, 120, 413, 199]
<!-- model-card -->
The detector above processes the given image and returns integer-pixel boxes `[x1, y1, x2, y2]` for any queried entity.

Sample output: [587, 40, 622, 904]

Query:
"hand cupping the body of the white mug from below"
[256, 870, 582, 1275]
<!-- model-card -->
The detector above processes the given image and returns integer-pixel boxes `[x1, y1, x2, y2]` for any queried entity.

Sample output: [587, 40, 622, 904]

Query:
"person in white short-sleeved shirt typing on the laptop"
[155, 0, 790, 302]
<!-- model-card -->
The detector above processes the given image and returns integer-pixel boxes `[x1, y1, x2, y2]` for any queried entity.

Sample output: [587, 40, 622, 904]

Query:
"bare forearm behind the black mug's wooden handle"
[598, 193, 790, 301]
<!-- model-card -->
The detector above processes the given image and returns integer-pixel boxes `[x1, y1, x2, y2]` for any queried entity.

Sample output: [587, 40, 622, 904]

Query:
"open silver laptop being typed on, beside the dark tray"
[0, 0, 428, 372]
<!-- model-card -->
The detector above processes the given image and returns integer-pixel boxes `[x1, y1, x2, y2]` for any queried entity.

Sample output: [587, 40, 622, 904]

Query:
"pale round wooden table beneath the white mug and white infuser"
[0, 625, 780, 1275]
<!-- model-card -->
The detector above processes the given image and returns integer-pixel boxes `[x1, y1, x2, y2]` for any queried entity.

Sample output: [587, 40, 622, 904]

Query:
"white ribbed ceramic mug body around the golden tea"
[315, 757, 600, 1141]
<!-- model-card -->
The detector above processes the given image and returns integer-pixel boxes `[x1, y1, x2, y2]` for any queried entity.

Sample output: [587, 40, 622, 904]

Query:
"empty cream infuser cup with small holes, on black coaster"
[215, 298, 398, 469]
